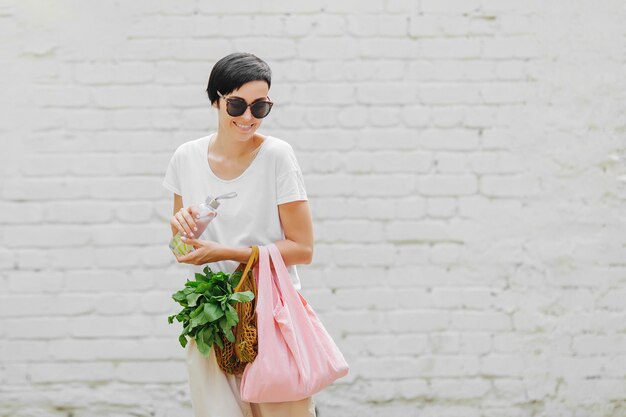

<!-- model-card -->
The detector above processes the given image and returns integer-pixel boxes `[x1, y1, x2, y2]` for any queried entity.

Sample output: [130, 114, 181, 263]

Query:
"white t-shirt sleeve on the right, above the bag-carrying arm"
[276, 144, 308, 204]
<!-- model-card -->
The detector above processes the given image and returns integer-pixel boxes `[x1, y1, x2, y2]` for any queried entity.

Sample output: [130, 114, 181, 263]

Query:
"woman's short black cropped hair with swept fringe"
[206, 52, 272, 104]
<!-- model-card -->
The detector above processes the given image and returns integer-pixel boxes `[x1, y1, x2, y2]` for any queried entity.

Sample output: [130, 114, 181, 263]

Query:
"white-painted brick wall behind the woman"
[0, 0, 626, 417]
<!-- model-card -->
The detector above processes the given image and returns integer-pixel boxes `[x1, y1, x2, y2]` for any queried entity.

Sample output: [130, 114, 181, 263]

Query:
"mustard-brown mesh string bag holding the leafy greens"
[213, 246, 259, 375]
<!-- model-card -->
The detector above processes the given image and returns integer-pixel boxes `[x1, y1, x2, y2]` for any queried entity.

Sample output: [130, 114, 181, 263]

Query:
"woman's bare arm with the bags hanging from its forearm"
[177, 200, 313, 265]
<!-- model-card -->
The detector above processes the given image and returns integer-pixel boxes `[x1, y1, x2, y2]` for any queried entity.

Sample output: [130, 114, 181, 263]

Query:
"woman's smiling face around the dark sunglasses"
[213, 81, 269, 141]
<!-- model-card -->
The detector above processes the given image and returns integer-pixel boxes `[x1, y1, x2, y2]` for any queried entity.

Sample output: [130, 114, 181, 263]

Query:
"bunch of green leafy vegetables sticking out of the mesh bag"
[167, 266, 254, 356]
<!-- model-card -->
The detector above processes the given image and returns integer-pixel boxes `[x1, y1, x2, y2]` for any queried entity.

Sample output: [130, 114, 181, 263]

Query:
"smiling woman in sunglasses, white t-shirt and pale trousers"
[163, 53, 315, 417]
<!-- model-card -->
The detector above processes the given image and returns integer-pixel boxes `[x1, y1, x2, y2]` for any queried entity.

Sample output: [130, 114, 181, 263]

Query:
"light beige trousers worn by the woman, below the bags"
[187, 339, 315, 417]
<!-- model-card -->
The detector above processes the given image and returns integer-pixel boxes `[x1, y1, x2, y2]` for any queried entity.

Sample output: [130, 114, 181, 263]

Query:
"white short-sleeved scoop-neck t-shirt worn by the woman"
[163, 134, 307, 289]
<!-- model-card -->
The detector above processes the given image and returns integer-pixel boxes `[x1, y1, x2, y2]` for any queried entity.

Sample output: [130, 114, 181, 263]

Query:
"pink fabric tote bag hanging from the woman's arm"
[241, 244, 348, 403]
